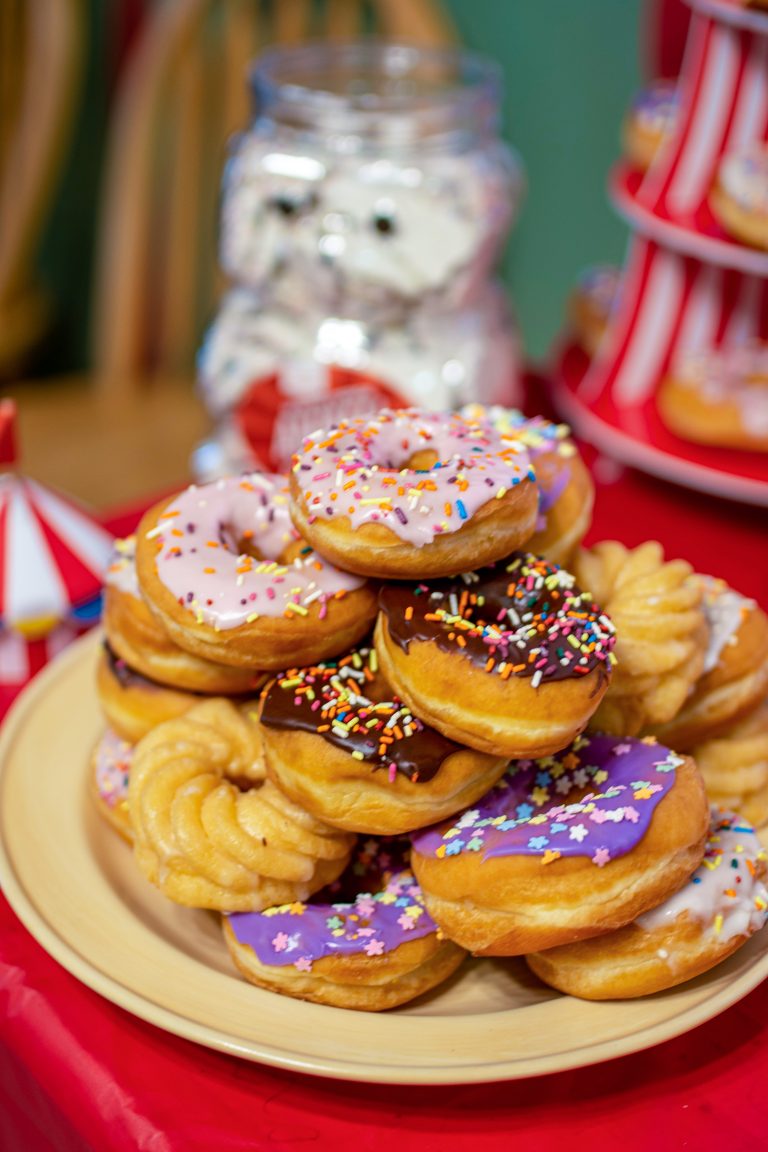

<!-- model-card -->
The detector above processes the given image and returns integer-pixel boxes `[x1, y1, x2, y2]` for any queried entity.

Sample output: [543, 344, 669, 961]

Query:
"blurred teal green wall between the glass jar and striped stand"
[446, 0, 642, 359]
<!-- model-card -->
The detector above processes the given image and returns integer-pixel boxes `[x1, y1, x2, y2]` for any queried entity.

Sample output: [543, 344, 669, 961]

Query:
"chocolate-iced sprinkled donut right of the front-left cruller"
[260, 647, 507, 834]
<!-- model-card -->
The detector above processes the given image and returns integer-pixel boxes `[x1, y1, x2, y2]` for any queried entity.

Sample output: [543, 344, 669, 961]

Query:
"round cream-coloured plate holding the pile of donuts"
[0, 634, 768, 1084]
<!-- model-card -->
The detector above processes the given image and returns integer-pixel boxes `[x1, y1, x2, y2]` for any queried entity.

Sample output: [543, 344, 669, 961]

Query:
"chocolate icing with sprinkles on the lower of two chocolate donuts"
[261, 647, 458, 783]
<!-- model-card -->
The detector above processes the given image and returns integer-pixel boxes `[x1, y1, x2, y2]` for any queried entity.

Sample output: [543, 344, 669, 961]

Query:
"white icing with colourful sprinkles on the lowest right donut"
[634, 808, 768, 941]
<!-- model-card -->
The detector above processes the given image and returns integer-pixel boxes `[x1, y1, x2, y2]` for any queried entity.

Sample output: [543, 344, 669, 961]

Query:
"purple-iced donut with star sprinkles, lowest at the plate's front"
[223, 839, 465, 1011]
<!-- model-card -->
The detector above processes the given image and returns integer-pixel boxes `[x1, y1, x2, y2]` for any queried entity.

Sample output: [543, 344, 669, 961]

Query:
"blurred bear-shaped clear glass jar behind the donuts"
[198, 41, 523, 478]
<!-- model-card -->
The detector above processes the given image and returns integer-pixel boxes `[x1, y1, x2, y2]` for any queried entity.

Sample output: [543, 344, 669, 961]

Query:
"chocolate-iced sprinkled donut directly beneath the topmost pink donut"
[374, 552, 615, 757]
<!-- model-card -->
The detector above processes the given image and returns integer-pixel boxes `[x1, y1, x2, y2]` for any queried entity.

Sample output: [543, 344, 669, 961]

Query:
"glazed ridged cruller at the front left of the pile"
[128, 697, 353, 911]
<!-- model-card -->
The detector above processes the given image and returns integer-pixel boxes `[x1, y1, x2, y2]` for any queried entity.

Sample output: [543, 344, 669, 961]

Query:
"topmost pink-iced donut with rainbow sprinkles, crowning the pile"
[285, 408, 538, 578]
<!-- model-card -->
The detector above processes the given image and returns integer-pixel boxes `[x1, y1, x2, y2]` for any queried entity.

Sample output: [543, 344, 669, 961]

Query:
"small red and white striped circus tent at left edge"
[0, 401, 113, 685]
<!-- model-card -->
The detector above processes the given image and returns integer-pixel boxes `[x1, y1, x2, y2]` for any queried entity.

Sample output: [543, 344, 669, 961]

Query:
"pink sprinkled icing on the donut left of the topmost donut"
[147, 472, 364, 630]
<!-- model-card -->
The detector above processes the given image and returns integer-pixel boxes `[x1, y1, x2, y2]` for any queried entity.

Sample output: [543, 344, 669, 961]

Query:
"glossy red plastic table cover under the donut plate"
[0, 433, 768, 1152]
